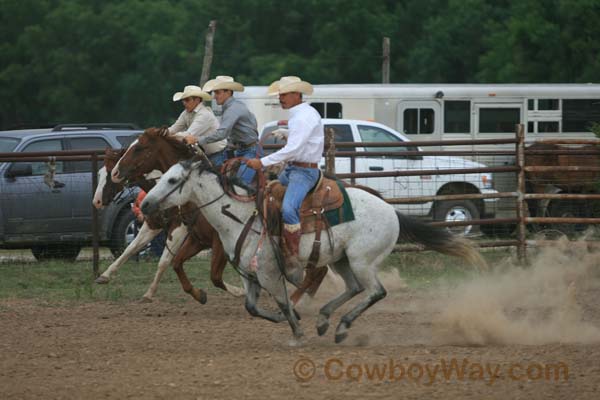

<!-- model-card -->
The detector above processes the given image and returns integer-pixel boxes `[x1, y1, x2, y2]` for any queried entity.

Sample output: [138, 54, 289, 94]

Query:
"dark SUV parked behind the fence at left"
[0, 124, 142, 259]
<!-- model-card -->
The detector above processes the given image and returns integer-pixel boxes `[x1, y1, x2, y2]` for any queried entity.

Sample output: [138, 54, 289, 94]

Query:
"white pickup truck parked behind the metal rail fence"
[261, 118, 497, 235]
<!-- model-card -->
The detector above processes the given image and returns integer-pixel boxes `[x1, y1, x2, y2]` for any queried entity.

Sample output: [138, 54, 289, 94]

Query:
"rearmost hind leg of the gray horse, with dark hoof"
[335, 260, 387, 343]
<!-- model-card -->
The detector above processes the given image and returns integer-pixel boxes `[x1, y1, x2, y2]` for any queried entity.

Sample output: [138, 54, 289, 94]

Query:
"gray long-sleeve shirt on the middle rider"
[198, 97, 258, 145]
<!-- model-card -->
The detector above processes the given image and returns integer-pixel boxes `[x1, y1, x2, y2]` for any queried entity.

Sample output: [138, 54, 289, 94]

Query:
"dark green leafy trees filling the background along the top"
[0, 0, 600, 129]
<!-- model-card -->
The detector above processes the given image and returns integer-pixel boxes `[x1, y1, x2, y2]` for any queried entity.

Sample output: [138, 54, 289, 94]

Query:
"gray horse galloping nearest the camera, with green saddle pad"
[142, 156, 485, 343]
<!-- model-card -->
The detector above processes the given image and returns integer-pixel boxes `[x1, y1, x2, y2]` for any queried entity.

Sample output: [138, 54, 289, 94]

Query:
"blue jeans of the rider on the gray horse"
[279, 165, 320, 224]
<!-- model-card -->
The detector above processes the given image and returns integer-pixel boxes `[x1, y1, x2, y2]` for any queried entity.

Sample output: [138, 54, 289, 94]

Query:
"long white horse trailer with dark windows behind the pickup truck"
[235, 84, 600, 216]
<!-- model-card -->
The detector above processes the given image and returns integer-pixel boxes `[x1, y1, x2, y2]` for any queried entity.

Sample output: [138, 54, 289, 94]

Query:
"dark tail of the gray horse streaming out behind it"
[396, 211, 487, 269]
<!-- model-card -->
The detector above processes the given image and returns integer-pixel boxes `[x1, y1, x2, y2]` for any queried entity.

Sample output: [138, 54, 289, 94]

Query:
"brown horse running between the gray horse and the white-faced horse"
[107, 127, 244, 302]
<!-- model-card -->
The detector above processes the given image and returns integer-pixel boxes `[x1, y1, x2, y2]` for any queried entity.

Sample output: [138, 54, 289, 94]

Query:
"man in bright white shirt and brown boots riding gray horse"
[246, 76, 325, 272]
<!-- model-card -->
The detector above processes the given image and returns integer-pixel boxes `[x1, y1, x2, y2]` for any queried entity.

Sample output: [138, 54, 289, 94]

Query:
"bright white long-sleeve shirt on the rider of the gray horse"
[260, 103, 325, 167]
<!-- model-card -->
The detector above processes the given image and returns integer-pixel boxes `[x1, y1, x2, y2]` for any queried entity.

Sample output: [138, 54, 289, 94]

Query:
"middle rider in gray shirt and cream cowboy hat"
[198, 76, 262, 183]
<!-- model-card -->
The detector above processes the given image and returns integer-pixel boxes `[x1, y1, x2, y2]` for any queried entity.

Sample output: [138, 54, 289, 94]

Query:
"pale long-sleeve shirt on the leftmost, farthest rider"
[169, 103, 227, 155]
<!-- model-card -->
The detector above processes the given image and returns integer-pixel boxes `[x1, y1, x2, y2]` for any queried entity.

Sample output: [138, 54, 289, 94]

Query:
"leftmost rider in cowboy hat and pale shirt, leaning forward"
[169, 85, 227, 166]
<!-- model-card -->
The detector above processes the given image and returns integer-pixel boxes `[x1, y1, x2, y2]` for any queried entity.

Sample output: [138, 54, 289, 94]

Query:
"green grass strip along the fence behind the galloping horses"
[0, 249, 510, 304]
